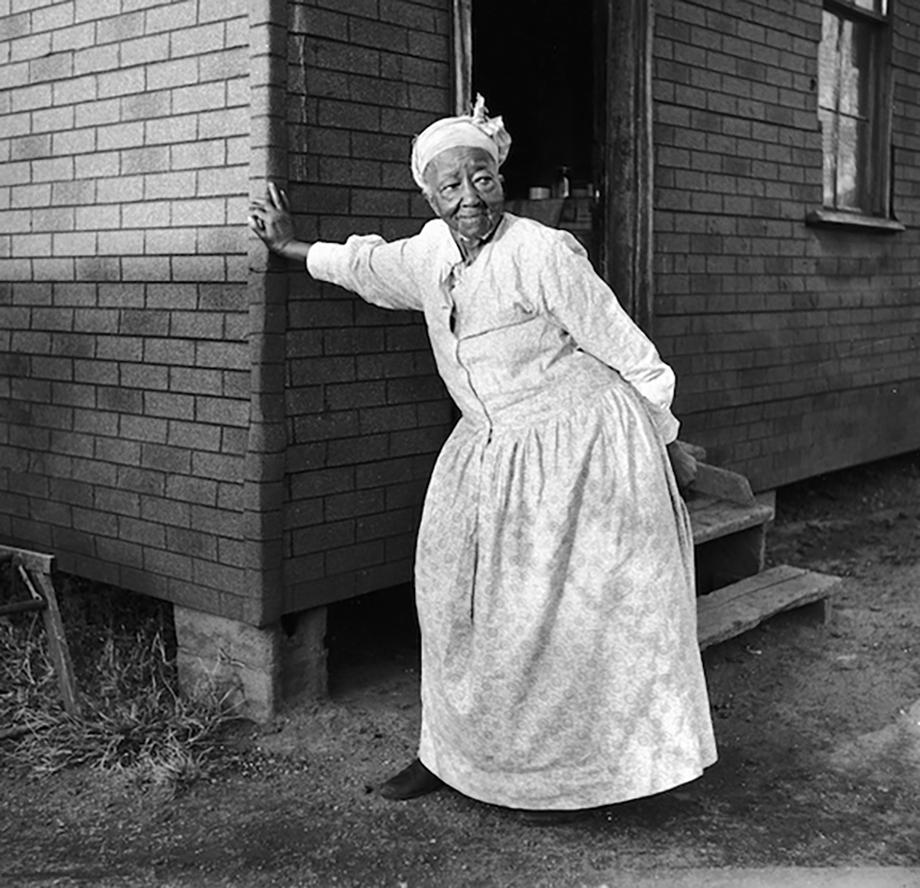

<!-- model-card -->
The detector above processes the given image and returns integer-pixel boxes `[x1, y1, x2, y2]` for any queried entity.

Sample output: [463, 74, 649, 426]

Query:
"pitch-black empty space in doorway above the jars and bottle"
[471, 0, 599, 199]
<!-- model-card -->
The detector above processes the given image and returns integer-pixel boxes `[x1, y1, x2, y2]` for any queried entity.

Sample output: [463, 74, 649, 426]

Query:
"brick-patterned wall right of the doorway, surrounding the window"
[654, 0, 920, 488]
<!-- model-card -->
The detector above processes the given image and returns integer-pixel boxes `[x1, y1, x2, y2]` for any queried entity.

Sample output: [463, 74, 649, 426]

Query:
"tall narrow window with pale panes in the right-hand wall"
[814, 0, 900, 227]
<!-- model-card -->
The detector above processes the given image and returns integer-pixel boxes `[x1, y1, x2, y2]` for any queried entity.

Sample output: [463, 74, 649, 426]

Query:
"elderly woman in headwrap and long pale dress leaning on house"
[249, 99, 715, 812]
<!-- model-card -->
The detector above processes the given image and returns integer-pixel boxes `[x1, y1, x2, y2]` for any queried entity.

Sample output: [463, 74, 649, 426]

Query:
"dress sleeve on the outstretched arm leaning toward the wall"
[307, 234, 422, 311]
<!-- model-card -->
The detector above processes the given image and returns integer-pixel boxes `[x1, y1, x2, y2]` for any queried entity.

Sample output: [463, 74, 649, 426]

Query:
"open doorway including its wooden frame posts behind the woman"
[453, 0, 655, 332]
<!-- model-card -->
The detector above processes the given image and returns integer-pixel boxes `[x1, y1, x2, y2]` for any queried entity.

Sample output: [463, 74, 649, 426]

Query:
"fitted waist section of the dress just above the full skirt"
[460, 355, 638, 432]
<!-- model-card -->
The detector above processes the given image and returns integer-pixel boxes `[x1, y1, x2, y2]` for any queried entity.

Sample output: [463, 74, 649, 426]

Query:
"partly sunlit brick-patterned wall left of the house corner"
[0, 0, 249, 616]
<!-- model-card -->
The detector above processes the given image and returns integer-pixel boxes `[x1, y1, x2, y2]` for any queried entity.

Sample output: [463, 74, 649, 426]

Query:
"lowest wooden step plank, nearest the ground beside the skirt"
[696, 564, 841, 648]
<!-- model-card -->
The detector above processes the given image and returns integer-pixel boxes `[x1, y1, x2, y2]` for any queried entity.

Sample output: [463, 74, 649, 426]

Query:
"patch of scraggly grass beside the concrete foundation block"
[0, 575, 236, 794]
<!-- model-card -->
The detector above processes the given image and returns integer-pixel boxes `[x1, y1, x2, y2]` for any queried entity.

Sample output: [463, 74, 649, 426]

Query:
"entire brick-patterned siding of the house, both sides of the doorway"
[16, 0, 920, 622]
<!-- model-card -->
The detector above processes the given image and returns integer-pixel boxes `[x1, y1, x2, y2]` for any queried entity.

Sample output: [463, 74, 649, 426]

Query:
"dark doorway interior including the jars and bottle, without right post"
[455, 0, 606, 260]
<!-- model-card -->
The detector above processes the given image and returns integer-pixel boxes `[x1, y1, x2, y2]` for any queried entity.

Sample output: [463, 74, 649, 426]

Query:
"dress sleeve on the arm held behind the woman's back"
[541, 232, 680, 444]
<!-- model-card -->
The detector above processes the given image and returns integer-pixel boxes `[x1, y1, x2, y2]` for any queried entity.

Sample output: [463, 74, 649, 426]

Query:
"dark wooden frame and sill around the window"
[806, 0, 904, 231]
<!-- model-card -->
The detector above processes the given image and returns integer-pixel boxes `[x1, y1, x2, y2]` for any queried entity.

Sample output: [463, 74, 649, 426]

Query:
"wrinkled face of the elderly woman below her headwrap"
[425, 147, 505, 241]
